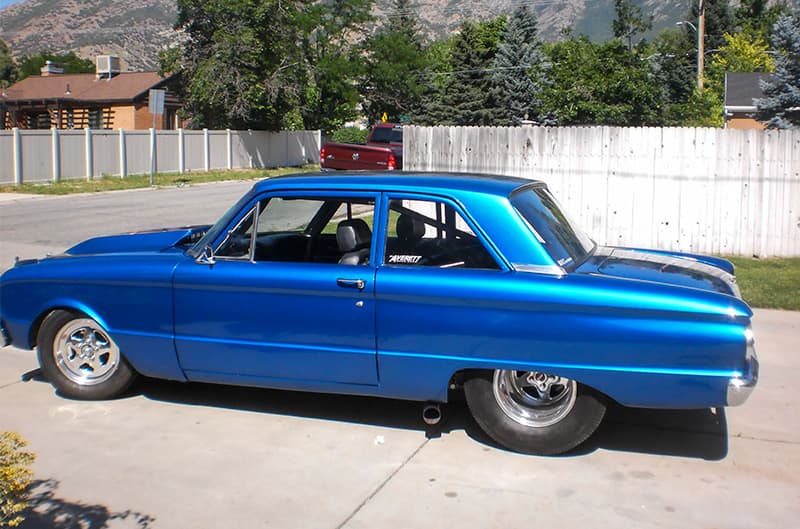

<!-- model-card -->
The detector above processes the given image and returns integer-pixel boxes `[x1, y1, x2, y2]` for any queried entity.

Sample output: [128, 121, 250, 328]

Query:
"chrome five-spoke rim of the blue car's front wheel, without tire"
[53, 318, 120, 386]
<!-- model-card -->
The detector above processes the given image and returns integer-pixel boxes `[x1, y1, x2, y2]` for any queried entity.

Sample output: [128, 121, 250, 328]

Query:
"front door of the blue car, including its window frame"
[174, 193, 377, 387]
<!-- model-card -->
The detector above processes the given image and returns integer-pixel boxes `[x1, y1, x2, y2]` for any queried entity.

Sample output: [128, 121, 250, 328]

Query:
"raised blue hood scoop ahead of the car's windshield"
[65, 226, 210, 255]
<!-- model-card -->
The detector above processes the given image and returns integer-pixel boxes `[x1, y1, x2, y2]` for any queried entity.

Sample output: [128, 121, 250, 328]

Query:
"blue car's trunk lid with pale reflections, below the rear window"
[577, 246, 741, 298]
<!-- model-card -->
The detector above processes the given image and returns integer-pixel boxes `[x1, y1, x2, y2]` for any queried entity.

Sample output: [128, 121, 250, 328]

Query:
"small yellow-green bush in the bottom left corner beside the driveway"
[0, 432, 35, 527]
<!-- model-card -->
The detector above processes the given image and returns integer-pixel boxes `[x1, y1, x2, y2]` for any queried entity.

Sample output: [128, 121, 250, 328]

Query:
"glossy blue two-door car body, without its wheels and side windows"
[0, 173, 757, 408]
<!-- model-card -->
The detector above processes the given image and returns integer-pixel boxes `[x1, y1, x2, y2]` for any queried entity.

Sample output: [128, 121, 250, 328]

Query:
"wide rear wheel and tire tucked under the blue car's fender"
[464, 370, 606, 455]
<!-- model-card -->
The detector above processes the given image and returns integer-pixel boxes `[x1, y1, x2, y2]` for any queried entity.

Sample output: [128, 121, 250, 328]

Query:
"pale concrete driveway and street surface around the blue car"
[0, 183, 800, 529]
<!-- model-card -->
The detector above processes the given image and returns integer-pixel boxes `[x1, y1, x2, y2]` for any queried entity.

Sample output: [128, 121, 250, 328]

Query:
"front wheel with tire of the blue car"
[38, 310, 136, 400]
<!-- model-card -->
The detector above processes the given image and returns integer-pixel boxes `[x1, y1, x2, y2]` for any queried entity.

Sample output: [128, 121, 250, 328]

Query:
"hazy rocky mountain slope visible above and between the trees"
[0, 0, 690, 70]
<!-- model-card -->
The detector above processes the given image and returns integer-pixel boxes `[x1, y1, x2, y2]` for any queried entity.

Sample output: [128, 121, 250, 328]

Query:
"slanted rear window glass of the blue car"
[511, 186, 595, 269]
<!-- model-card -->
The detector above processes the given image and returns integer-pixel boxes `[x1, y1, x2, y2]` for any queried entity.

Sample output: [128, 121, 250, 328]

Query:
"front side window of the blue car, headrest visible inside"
[215, 196, 375, 265]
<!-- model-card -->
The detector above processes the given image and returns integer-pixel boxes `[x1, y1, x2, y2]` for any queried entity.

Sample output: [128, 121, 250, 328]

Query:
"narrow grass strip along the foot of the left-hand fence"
[0, 165, 319, 195]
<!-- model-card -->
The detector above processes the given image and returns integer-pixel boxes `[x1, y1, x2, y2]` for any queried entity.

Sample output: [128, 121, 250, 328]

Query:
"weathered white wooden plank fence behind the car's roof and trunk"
[403, 127, 800, 257]
